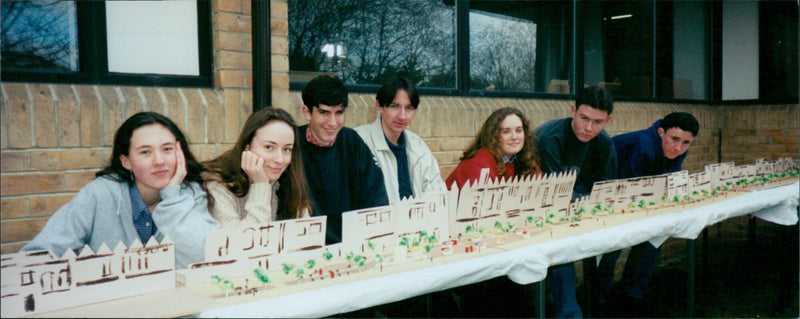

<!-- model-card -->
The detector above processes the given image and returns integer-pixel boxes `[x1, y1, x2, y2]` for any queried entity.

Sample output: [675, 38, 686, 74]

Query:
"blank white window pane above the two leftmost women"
[106, 1, 200, 75]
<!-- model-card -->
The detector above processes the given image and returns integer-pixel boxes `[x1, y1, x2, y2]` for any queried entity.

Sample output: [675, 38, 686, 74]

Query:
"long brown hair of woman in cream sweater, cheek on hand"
[203, 107, 311, 220]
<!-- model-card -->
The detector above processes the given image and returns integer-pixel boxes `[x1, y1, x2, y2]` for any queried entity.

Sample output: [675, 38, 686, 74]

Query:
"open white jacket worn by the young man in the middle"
[355, 116, 446, 205]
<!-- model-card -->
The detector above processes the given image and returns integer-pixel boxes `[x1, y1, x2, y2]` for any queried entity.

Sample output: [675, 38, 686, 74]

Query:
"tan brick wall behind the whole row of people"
[0, 0, 799, 270]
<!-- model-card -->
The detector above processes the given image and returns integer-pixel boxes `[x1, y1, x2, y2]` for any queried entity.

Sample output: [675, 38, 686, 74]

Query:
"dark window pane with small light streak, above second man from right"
[581, 0, 654, 97]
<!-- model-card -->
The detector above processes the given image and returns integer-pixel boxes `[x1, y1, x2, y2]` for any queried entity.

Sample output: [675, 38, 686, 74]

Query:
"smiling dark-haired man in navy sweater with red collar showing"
[298, 75, 389, 244]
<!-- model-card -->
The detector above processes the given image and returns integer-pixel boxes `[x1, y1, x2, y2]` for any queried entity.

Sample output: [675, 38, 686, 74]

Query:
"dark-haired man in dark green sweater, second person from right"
[536, 86, 617, 318]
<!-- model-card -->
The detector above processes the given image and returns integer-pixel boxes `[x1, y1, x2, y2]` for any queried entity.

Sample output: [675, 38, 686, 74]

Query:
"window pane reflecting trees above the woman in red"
[469, 1, 573, 94]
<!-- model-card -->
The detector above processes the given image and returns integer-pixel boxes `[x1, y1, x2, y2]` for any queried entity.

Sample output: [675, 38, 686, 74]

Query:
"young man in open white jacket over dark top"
[355, 77, 446, 204]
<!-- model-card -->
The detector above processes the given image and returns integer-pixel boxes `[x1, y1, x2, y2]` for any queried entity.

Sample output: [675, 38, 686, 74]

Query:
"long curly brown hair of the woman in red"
[459, 107, 539, 176]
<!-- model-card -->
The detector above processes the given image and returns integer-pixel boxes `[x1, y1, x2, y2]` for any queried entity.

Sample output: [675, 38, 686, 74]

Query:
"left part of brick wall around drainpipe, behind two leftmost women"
[0, 0, 256, 253]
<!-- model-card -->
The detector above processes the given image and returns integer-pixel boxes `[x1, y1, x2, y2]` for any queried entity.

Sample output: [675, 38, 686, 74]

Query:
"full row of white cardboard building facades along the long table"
[0, 158, 800, 317]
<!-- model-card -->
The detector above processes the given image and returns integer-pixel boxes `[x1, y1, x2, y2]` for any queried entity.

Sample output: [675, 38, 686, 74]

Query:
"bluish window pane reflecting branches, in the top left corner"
[0, 1, 79, 71]
